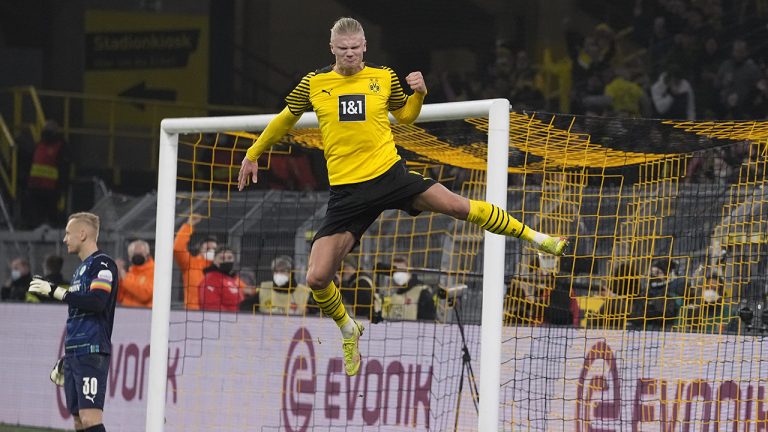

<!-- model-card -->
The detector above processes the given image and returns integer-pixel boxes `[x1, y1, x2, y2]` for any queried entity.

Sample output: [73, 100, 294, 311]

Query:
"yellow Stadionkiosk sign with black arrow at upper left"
[84, 10, 209, 126]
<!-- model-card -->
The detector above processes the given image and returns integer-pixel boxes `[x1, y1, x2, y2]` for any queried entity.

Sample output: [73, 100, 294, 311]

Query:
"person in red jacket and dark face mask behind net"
[198, 246, 244, 312]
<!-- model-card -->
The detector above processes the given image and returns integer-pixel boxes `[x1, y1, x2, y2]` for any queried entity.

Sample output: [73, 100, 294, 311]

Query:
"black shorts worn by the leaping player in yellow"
[313, 160, 437, 243]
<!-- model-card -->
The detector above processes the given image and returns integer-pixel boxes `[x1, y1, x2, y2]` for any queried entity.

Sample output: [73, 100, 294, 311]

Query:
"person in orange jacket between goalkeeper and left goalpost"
[117, 240, 155, 308]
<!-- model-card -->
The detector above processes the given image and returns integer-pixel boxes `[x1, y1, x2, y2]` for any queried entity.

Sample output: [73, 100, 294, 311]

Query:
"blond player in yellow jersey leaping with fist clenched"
[238, 18, 567, 375]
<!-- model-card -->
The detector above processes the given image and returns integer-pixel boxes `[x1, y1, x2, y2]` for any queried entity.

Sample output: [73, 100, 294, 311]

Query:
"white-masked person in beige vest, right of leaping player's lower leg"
[382, 255, 436, 321]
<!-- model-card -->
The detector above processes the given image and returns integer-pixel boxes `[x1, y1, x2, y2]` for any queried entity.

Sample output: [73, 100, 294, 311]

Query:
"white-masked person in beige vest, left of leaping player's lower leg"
[240, 255, 313, 315]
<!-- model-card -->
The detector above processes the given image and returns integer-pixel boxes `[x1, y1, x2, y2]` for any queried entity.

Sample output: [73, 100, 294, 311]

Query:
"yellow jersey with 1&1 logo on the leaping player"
[285, 64, 420, 186]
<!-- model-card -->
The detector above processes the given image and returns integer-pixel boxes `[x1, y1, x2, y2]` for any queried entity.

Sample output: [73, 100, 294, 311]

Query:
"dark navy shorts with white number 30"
[64, 354, 109, 415]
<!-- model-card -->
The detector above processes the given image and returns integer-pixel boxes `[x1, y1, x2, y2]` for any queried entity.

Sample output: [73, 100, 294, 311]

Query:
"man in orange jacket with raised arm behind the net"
[173, 214, 218, 310]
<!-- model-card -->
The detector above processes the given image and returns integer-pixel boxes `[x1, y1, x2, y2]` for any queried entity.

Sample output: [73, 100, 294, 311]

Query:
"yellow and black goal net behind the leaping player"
[147, 102, 768, 431]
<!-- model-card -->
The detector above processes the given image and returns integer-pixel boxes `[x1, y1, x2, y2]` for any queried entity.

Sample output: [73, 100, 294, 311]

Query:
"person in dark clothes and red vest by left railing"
[22, 120, 69, 228]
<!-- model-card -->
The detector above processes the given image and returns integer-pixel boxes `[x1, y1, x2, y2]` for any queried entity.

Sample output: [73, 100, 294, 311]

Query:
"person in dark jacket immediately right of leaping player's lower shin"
[339, 257, 381, 321]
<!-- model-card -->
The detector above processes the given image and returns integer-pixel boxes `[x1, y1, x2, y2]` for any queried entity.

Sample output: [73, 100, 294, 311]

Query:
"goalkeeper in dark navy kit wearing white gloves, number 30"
[29, 213, 118, 432]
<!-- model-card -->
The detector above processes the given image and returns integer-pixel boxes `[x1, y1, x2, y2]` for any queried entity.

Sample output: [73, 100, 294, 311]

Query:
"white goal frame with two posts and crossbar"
[146, 99, 510, 432]
